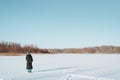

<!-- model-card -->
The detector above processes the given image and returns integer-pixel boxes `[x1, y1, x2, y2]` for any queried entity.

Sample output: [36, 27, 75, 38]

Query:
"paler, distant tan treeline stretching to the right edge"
[48, 46, 120, 53]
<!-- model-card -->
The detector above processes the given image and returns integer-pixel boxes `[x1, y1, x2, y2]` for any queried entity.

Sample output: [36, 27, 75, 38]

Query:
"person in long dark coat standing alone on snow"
[26, 50, 33, 72]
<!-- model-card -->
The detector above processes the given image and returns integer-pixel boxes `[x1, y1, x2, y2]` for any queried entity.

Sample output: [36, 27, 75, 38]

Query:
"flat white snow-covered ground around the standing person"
[0, 54, 120, 80]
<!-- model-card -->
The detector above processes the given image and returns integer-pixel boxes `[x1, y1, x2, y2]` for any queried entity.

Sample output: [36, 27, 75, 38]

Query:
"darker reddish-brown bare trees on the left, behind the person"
[0, 41, 49, 53]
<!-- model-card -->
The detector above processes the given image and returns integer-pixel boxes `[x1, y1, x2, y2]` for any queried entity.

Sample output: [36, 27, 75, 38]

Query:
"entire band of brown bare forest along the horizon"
[0, 41, 120, 54]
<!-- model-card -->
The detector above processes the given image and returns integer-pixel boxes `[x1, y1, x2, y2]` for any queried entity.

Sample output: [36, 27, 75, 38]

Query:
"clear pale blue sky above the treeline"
[0, 0, 120, 48]
